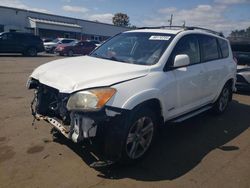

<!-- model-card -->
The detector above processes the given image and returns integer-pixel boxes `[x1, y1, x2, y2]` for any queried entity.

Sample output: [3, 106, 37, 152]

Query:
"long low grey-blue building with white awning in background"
[0, 6, 128, 40]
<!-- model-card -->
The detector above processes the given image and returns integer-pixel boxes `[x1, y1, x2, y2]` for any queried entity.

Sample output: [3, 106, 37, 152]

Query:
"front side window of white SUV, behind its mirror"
[173, 35, 200, 64]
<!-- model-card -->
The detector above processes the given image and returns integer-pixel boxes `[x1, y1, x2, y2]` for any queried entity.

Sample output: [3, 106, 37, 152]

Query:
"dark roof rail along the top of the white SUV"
[137, 26, 224, 37]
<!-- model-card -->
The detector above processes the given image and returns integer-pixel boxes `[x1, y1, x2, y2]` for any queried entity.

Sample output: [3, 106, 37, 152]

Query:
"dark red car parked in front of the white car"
[55, 41, 96, 56]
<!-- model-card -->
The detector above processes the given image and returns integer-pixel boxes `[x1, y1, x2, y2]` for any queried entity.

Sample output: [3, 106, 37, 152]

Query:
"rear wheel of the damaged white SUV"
[212, 84, 232, 115]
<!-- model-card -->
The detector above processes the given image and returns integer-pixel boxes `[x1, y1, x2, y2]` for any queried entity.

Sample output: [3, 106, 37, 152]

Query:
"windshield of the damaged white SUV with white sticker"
[90, 32, 173, 65]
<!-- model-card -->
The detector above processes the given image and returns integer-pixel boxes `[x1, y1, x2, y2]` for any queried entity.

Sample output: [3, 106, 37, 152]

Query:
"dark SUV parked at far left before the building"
[0, 32, 44, 57]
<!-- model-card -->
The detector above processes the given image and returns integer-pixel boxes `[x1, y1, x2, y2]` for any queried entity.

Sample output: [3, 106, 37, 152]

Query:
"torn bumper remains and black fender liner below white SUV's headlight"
[36, 107, 130, 161]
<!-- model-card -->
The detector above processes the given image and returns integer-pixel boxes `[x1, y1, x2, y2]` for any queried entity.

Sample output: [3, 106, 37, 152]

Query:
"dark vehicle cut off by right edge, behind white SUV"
[231, 42, 250, 91]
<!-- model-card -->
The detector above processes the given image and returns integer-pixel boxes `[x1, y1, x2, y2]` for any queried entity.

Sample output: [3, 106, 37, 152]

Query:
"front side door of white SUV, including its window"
[165, 35, 206, 117]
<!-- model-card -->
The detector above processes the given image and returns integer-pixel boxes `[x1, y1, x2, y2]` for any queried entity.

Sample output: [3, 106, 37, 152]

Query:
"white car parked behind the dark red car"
[44, 38, 78, 53]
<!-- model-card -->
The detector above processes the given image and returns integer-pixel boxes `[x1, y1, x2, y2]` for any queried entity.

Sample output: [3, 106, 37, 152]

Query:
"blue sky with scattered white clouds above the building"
[0, 0, 250, 35]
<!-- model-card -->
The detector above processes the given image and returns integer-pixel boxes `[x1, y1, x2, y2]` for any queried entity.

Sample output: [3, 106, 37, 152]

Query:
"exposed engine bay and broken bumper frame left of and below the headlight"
[28, 79, 103, 143]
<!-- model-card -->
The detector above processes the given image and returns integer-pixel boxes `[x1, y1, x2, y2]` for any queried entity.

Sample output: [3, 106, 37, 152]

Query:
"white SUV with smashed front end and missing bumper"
[28, 27, 236, 161]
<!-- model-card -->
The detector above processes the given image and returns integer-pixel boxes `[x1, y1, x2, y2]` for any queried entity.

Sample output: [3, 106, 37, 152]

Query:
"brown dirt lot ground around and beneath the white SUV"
[0, 55, 250, 188]
